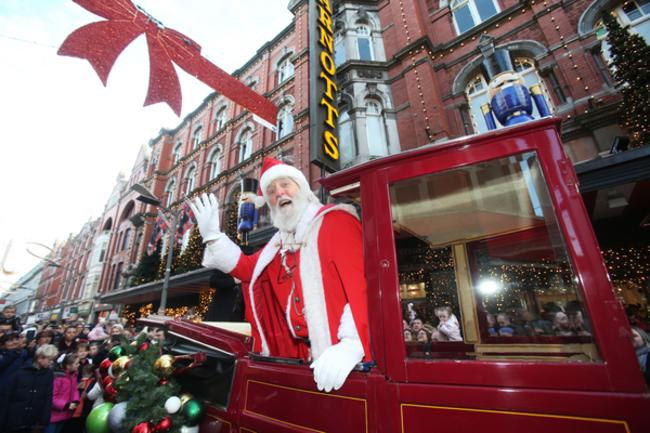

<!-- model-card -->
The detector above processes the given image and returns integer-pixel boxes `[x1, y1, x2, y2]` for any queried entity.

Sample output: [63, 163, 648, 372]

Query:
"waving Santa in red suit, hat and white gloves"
[191, 157, 372, 392]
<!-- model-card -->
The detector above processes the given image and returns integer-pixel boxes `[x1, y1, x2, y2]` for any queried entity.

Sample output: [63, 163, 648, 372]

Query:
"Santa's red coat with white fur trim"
[203, 204, 372, 361]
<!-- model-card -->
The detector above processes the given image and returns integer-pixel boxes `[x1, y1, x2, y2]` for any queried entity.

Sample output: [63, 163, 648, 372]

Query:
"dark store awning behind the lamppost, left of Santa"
[100, 268, 212, 304]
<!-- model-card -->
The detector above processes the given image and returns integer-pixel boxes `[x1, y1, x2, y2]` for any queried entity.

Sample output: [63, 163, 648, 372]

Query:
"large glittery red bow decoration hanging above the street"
[58, 0, 277, 125]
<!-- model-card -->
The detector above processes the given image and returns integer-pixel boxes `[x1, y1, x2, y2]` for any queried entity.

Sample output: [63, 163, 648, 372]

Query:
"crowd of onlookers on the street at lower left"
[0, 305, 165, 433]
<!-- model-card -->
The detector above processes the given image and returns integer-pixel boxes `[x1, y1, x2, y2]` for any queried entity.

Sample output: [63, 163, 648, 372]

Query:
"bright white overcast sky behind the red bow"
[0, 0, 293, 288]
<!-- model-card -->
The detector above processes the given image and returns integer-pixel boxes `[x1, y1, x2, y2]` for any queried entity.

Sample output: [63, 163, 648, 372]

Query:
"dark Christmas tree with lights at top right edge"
[602, 11, 650, 147]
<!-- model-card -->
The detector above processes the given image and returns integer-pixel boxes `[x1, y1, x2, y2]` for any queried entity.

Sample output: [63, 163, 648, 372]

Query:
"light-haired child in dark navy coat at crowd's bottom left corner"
[0, 344, 59, 432]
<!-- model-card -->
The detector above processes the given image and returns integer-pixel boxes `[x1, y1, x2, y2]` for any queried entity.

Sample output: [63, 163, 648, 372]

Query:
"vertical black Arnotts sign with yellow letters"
[309, 0, 340, 171]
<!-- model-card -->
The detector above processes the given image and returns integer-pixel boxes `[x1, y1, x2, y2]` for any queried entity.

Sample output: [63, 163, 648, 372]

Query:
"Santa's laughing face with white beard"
[266, 177, 309, 232]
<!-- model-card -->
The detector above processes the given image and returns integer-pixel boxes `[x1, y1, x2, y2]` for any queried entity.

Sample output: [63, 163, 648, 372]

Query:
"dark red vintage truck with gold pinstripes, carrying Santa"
[145, 118, 650, 433]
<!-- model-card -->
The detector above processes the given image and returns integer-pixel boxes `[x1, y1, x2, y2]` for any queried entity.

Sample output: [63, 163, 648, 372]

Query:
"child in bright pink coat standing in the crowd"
[43, 352, 79, 433]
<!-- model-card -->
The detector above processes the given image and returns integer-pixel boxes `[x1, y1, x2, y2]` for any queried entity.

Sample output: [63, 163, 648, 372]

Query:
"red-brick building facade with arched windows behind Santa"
[33, 0, 650, 318]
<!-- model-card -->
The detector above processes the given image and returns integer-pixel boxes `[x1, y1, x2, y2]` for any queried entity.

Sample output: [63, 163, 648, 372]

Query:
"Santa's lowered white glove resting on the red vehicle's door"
[310, 338, 363, 392]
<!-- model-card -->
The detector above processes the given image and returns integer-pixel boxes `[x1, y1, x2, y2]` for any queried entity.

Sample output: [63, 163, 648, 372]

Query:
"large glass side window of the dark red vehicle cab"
[390, 152, 600, 362]
